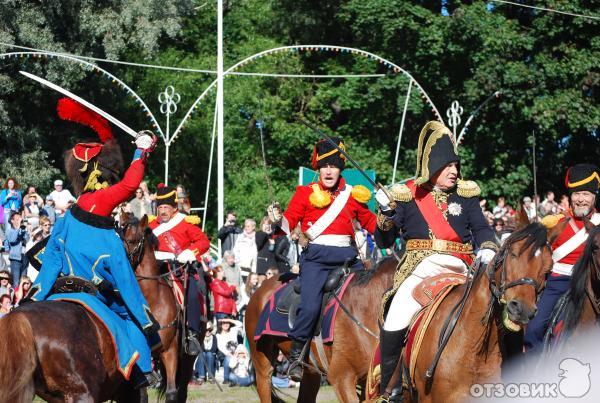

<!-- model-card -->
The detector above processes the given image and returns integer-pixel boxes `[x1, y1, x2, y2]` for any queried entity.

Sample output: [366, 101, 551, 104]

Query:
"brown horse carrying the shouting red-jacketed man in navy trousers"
[245, 258, 398, 402]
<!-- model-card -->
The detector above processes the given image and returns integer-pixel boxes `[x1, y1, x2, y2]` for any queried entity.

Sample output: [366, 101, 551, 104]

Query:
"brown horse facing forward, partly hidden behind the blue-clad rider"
[119, 212, 204, 403]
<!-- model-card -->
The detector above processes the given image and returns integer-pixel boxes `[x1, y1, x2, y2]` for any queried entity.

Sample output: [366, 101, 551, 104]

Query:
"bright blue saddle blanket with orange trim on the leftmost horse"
[47, 293, 145, 380]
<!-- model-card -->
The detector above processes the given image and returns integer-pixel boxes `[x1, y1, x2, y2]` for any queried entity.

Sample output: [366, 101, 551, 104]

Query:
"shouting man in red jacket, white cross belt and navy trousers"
[269, 138, 376, 381]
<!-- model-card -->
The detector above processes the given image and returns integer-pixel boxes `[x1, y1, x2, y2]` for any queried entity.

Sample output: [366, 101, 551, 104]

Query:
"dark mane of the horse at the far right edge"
[562, 227, 600, 336]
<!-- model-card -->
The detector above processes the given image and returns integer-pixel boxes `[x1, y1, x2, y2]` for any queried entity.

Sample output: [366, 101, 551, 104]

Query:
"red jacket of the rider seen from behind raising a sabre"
[77, 158, 146, 217]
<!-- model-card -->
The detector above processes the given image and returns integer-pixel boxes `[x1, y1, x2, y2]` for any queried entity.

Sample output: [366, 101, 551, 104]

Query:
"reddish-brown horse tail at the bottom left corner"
[0, 312, 37, 403]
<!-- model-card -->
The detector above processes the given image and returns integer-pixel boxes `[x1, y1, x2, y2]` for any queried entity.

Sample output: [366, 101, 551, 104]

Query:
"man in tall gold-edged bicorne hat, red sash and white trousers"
[375, 121, 498, 400]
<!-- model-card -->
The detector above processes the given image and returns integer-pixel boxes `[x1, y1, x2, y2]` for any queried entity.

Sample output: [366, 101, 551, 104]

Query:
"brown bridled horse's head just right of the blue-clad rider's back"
[119, 212, 155, 270]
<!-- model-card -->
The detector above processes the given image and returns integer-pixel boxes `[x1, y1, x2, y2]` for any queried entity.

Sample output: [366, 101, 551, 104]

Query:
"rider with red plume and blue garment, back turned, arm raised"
[28, 98, 159, 387]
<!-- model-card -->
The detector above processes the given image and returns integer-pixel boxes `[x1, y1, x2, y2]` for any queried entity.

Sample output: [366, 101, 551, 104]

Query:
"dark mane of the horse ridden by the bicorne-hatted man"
[473, 223, 548, 354]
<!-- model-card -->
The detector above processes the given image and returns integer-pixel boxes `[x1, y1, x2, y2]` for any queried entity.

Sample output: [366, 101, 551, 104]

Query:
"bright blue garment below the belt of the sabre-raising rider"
[31, 207, 152, 329]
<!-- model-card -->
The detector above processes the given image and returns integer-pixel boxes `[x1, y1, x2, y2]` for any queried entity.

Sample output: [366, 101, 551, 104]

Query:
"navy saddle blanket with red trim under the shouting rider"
[254, 273, 354, 343]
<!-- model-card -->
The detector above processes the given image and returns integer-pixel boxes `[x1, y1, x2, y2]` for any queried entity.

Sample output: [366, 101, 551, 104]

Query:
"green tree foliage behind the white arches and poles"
[0, 0, 600, 235]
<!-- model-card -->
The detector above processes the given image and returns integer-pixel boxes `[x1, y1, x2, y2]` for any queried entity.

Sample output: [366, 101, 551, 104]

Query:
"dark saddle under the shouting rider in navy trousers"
[275, 267, 350, 329]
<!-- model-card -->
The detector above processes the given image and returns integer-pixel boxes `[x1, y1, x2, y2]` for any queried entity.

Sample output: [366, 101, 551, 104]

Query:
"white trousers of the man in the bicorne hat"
[383, 253, 467, 331]
